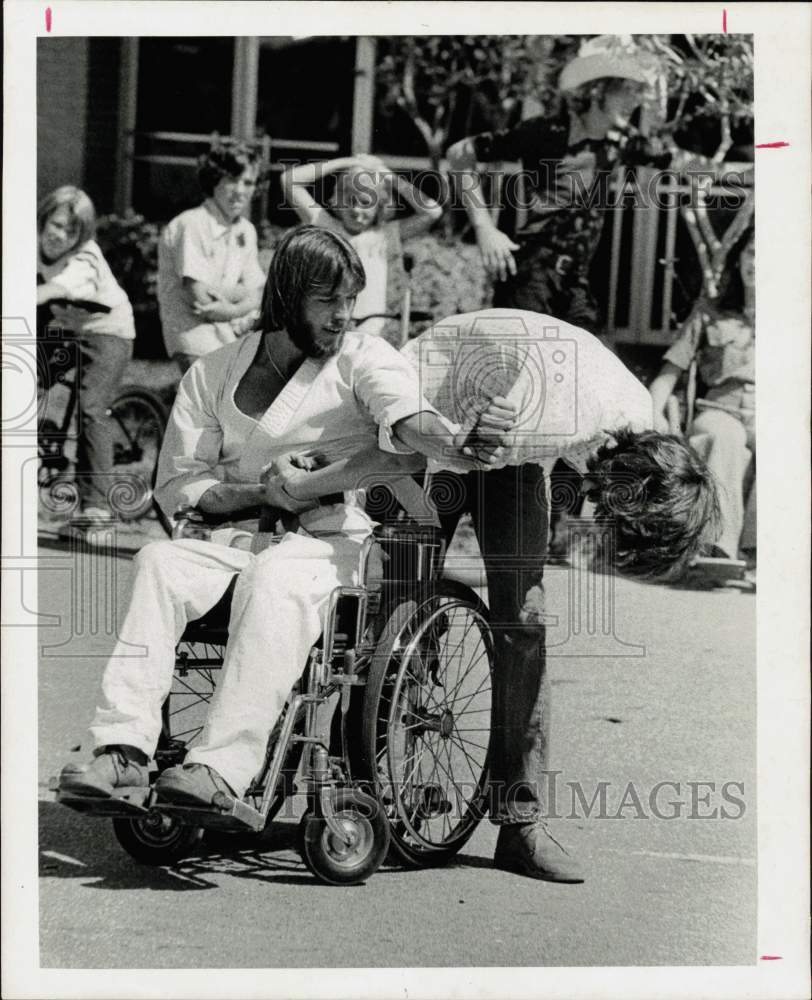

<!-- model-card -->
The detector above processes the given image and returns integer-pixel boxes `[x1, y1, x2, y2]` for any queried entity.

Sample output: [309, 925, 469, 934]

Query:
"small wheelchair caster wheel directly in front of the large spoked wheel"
[300, 788, 389, 885]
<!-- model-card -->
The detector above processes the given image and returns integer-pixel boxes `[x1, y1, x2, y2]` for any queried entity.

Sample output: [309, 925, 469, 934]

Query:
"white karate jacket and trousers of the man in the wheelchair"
[91, 333, 435, 795]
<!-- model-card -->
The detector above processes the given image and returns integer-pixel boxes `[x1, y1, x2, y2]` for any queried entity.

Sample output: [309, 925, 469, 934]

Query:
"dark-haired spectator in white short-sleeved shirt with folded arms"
[158, 141, 265, 372]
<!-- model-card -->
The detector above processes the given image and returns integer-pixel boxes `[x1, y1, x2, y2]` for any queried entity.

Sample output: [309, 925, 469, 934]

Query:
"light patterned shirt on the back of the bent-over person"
[403, 309, 654, 468]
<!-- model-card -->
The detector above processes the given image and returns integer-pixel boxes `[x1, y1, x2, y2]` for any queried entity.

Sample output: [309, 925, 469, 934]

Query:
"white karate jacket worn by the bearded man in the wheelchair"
[155, 332, 444, 528]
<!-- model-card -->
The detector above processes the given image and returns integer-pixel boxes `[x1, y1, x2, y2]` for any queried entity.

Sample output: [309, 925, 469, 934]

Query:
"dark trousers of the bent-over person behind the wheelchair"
[432, 465, 550, 823]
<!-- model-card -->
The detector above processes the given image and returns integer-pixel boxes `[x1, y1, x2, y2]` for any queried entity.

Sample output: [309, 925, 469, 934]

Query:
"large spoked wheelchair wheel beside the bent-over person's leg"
[362, 580, 493, 866]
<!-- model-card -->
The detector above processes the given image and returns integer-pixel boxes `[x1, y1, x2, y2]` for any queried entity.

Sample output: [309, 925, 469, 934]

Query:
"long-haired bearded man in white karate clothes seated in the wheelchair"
[60, 226, 510, 824]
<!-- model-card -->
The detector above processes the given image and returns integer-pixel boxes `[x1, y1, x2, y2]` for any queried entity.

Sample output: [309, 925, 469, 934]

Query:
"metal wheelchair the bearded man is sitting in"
[57, 498, 493, 885]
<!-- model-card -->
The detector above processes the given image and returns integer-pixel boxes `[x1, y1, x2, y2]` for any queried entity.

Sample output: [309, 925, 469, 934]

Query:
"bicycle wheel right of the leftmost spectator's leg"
[109, 386, 167, 520]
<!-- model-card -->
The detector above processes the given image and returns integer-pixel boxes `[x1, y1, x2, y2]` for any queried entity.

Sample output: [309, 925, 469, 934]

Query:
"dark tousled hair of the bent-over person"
[587, 428, 720, 578]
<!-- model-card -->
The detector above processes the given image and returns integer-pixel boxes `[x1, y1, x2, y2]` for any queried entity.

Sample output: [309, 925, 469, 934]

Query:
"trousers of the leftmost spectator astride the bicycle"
[37, 329, 132, 508]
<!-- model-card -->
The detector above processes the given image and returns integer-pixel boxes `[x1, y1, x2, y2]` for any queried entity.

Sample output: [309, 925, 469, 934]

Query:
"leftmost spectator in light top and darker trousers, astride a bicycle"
[37, 185, 135, 527]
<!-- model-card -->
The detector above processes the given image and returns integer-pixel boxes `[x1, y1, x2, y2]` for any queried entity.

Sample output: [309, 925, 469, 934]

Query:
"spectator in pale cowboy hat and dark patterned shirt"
[447, 35, 670, 557]
